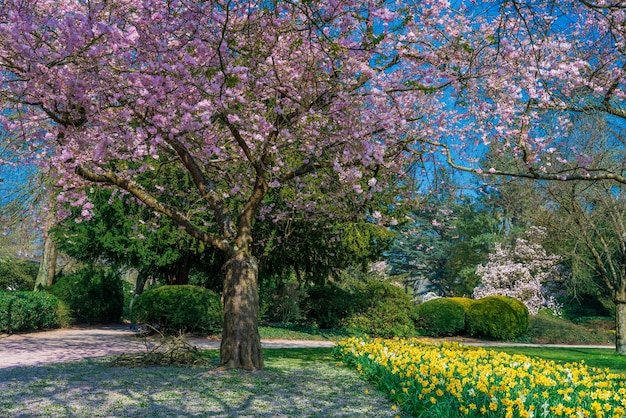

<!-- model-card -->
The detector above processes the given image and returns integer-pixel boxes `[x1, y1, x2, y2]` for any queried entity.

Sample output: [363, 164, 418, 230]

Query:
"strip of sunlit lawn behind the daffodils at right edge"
[490, 347, 626, 374]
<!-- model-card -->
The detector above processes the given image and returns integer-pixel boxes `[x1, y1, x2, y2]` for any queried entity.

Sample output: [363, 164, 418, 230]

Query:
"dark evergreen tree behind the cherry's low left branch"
[52, 188, 224, 286]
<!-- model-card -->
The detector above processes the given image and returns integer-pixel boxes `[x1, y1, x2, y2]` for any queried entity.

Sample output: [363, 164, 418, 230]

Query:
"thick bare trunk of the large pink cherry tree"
[220, 254, 263, 370]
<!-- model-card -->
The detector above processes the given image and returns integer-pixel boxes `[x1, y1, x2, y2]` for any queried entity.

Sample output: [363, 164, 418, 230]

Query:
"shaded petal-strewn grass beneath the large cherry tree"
[0, 348, 404, 417]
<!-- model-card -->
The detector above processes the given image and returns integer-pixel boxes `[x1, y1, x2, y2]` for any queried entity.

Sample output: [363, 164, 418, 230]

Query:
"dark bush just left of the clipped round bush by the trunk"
[48, 265, 124, 324]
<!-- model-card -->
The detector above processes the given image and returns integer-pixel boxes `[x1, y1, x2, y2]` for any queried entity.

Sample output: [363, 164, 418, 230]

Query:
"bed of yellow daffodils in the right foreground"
[335, 338, 626, 418]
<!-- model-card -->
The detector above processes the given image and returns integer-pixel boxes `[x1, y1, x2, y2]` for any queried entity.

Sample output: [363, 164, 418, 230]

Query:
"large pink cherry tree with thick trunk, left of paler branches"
[0, 0, 428, 369]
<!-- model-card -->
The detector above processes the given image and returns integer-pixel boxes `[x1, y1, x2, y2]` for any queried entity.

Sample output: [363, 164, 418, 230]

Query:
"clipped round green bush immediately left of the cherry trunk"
[131, 285, 224, 334]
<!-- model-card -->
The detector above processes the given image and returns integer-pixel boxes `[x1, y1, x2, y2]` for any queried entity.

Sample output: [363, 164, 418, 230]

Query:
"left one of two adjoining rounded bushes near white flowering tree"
[415, 298, 472, 337]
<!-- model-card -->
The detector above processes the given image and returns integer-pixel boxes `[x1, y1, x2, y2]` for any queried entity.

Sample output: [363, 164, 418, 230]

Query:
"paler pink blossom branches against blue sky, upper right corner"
[428, 0, 626, 183]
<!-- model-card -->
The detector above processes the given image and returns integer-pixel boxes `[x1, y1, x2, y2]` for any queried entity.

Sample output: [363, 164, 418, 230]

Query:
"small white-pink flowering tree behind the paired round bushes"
[474, 226, 560, 315]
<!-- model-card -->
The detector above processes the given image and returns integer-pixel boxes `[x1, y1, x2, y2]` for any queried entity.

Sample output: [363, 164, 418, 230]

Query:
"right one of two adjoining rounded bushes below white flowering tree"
[466, 296, 529, 340]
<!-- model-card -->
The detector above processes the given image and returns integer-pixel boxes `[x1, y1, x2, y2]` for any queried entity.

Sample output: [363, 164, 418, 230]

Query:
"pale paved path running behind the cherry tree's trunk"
[0, 325, 334, 369]
